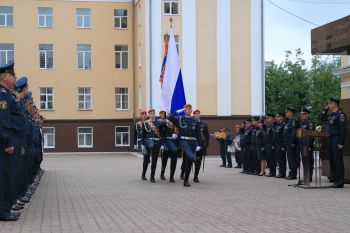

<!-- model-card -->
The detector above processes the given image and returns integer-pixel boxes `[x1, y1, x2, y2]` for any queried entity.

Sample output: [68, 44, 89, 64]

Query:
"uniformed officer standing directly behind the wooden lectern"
[298, 107, 315, 182]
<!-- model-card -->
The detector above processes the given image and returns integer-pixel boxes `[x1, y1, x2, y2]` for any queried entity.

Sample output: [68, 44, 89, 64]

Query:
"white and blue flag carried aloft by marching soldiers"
[159, 29, 186, 113]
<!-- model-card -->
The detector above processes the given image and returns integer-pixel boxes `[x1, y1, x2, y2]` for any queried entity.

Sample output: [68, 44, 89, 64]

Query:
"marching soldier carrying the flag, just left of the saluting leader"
[159, 110, 179, 183]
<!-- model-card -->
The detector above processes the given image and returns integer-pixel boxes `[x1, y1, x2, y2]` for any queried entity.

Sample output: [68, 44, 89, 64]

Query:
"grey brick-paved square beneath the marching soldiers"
[0, 154, 350, 233]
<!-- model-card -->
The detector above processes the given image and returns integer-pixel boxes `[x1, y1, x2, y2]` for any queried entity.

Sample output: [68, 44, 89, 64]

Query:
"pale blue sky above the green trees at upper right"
[264, 0, 350, 66]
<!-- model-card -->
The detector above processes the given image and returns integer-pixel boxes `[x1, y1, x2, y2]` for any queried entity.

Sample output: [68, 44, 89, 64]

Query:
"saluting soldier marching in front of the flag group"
[168, 104, 202, 187]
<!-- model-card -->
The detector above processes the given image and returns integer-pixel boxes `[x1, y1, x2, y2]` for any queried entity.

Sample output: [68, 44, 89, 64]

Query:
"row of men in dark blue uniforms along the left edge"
[0, 62, 44, 221]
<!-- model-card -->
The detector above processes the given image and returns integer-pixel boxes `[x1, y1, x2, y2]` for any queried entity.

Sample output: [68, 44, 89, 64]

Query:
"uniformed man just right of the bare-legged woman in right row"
[265, 114, 276, 177]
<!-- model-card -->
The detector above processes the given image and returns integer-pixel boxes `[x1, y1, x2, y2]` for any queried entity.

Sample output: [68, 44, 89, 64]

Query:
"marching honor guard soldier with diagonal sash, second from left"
[142, 108, 165, 183]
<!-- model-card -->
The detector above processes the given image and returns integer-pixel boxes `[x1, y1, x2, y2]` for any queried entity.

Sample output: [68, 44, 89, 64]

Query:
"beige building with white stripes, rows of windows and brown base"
[0, 0, 264, 151]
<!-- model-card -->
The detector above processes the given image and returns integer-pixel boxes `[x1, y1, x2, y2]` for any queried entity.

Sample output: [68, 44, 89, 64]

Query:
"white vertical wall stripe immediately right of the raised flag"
[182, 0, 196, 108]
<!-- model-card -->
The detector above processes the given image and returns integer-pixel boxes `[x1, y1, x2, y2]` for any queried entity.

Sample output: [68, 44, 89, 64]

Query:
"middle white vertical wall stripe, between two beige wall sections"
[216, 0, 232, 116]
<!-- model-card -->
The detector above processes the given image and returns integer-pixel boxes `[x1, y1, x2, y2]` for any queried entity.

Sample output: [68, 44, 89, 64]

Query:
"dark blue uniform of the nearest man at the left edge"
[0, 85, 26, 217]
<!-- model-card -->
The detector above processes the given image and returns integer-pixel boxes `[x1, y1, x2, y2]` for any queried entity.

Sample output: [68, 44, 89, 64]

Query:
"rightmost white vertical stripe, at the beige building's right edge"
[250, 0, 265, 115]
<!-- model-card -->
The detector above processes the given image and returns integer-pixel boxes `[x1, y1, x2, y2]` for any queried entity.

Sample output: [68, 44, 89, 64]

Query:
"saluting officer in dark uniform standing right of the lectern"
[320, 97, 347, 188]
